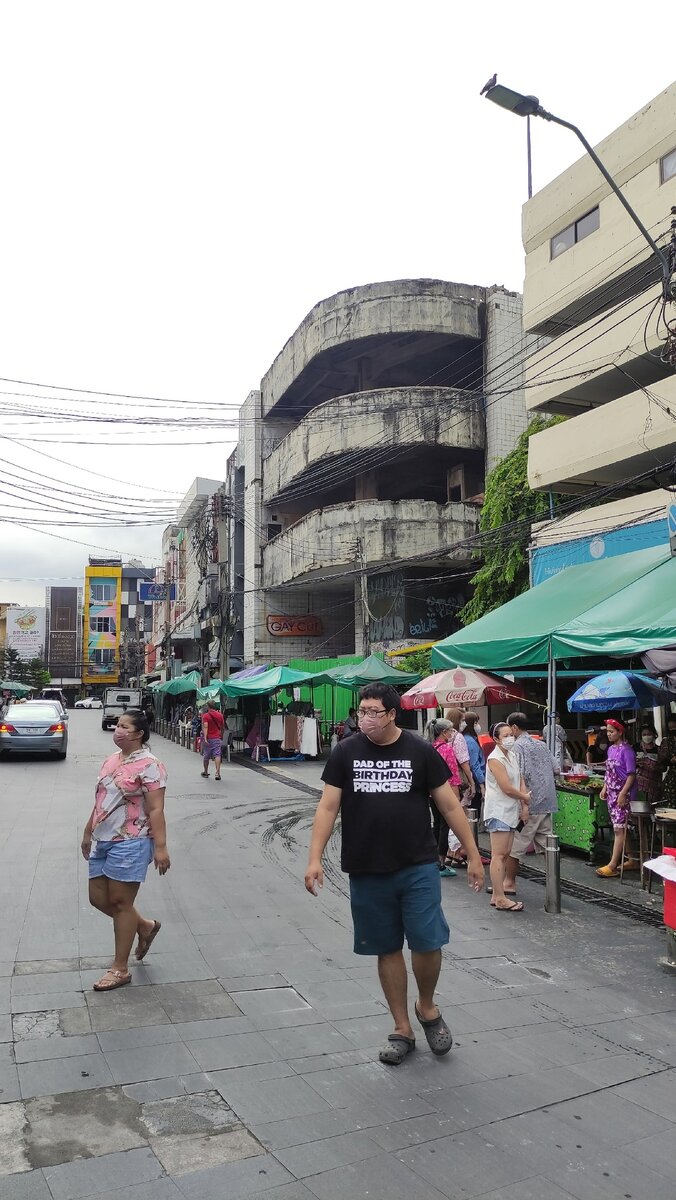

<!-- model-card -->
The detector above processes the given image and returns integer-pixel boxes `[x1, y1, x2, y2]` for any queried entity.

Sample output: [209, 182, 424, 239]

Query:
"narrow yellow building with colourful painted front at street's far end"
[82, 559, 122, 684]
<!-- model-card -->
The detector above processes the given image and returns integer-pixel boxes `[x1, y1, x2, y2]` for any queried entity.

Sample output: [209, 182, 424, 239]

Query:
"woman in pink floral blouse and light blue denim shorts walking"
[82, 709, 171, 991]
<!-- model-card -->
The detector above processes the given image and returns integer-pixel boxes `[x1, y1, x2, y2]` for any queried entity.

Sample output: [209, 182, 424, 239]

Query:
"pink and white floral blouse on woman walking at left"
[91, 746, 167, 841]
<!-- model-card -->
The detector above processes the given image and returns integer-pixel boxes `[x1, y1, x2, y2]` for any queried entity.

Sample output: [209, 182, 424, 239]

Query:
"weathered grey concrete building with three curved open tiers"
[227, 280, 527, 662]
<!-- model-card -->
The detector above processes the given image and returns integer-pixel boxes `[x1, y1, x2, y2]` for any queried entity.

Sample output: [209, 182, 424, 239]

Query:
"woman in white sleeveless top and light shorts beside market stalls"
[484, 722, 531, 912]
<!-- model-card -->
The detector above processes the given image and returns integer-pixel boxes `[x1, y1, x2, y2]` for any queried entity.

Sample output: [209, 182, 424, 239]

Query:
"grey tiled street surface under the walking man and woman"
[0, 712, 676, 1200]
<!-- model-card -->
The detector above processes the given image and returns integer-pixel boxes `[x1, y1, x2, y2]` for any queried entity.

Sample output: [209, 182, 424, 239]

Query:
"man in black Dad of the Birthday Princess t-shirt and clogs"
[305, 684, 484, 1066]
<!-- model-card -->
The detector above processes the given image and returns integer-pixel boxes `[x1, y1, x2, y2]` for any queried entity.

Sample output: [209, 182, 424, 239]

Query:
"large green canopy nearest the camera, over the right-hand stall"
[432, 546, 676, 671]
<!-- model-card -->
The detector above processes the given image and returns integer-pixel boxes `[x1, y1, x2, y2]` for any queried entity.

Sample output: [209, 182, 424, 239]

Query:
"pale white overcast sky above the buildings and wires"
[0, 0, 674, 604]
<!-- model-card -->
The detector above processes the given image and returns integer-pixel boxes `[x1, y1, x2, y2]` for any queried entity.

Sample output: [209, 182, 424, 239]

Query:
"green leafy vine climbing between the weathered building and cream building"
[459, 416, 566, 625]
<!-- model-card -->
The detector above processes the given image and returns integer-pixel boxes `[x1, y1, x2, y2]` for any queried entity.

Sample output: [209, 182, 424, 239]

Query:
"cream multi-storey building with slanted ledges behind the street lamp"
[524, 84, 676, 571]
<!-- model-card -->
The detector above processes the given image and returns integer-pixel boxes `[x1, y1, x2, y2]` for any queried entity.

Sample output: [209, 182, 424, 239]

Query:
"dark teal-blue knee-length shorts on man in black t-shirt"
[349, 863, 450, 954]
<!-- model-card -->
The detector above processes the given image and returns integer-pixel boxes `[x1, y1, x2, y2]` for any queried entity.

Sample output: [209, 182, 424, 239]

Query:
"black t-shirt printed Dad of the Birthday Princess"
[322, 730, 450, 875]
